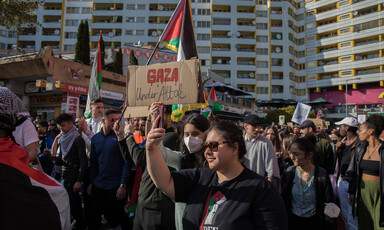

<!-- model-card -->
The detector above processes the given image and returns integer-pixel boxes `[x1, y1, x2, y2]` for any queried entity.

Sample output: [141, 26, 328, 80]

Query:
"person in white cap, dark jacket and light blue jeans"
[331, 117, 360, 230]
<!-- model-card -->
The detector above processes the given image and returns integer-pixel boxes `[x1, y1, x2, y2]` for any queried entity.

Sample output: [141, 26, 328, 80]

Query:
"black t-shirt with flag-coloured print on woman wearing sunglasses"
[171, 168, 288, 230]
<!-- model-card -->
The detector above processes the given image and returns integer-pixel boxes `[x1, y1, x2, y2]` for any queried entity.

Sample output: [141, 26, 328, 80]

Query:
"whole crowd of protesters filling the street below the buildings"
[0, 87, 384, 230]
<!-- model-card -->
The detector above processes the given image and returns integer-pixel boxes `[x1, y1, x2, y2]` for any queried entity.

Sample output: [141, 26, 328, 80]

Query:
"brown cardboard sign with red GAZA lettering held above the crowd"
[126, 59, 204, 107]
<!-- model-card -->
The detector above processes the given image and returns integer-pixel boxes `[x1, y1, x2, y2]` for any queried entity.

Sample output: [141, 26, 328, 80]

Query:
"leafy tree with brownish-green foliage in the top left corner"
[0, 0, 42, 54]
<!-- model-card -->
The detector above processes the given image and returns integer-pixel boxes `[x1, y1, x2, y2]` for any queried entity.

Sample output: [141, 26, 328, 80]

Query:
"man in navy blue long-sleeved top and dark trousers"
[87, 109, 130, 230]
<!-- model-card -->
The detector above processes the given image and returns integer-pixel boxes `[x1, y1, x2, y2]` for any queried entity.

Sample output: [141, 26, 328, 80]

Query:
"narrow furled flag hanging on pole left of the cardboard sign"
[85, 32, 104, 119]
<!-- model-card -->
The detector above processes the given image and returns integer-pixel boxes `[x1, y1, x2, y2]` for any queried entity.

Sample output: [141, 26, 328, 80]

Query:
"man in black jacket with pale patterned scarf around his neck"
[56, 113, 88, 229]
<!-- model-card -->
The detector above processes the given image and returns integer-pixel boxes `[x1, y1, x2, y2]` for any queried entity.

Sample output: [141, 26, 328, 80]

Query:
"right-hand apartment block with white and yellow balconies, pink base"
[305, 0, 384, 118]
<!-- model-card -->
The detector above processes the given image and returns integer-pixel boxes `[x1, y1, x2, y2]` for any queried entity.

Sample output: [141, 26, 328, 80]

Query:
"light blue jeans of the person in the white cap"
[337, 177, 357, 230]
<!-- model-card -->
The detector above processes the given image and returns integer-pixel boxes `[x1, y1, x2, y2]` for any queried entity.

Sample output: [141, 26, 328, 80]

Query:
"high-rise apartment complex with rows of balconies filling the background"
[7, 0, 384, 114]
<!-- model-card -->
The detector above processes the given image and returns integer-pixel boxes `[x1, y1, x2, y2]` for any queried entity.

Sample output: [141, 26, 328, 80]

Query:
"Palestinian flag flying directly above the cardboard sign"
[160, 0, 198, 61]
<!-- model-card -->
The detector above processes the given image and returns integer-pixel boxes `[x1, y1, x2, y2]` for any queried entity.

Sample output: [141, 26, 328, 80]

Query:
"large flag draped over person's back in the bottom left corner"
[0, 137, 71, 230]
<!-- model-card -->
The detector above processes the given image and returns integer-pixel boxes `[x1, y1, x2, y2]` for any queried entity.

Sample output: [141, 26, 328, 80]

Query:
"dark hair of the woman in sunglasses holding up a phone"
[203, 120, 247, 160]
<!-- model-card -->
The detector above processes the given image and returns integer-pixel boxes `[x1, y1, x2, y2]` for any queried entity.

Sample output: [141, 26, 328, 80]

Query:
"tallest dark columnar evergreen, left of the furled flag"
[75, 20, 90, 65]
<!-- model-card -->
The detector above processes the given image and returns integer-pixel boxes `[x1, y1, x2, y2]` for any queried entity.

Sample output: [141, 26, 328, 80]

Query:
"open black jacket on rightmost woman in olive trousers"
[347, 142, 384, 227]
